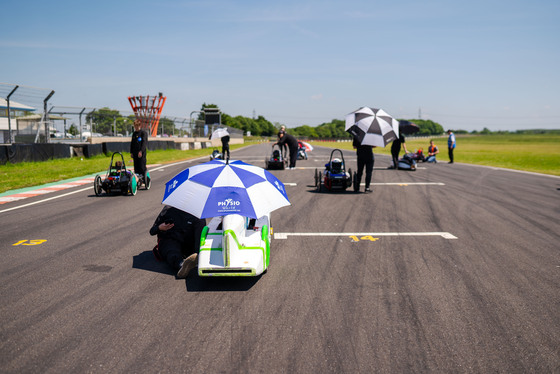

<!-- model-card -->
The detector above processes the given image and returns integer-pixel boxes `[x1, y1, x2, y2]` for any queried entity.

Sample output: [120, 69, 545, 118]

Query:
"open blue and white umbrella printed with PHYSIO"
[161, 160, 290, 218]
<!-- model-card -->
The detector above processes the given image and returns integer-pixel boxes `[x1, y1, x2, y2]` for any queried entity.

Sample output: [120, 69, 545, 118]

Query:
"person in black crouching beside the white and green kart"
[150, 205, 206, 279]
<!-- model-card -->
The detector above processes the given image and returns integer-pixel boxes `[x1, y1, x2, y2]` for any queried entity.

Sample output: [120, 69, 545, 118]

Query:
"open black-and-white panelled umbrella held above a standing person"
[345, 107, 399, 147]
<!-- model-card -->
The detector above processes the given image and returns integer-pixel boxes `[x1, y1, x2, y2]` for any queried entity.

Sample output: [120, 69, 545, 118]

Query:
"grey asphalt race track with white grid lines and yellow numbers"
[0, 144, 560, 373]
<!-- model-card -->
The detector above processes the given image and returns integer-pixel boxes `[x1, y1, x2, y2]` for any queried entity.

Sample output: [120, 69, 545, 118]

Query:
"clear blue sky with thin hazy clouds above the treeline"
[0, 0, 560, 131]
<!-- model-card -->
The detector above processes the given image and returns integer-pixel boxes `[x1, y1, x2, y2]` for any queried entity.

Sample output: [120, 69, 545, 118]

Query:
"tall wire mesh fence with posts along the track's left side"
[0, 83, 243, 143]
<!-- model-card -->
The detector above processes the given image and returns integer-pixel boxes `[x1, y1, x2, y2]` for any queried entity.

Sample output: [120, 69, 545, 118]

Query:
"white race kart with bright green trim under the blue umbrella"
[198, 213, 272, 277]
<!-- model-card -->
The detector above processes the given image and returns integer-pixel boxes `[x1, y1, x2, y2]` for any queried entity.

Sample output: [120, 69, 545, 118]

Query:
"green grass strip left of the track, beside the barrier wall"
[0, 144, 244, 193]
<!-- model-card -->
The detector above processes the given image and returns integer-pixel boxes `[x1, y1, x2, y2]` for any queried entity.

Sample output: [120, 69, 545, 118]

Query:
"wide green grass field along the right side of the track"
[311, 134, 560, 175]
